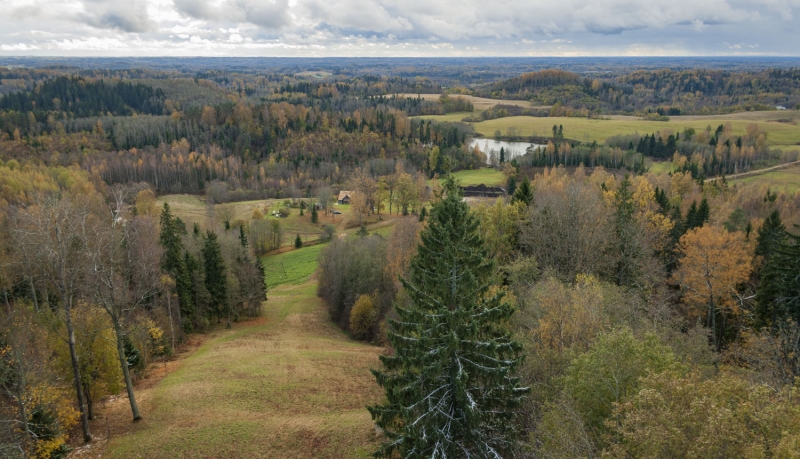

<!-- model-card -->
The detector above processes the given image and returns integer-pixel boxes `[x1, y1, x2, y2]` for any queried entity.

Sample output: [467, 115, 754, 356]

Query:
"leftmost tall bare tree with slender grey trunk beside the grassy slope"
[11, 196, 97, 443]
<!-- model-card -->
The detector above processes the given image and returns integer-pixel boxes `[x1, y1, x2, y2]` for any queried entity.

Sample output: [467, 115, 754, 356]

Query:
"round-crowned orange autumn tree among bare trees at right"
[673, 225, 752, 349]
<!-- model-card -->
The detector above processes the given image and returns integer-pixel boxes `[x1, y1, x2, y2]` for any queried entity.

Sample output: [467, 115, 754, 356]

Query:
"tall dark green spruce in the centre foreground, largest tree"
[369, 178, 527, 459]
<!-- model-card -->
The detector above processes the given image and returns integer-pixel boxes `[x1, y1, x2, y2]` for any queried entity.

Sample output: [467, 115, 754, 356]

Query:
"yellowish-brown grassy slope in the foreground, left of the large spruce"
[73, 280, 382, 459]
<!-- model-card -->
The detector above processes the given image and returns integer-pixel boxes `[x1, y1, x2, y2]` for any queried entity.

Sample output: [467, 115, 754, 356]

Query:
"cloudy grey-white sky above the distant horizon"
[0, 0, 800, 57]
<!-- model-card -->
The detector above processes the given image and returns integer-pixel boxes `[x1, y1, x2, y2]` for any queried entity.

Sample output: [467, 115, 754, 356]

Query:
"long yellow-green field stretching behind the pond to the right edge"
[416, 111, 800, 150]
